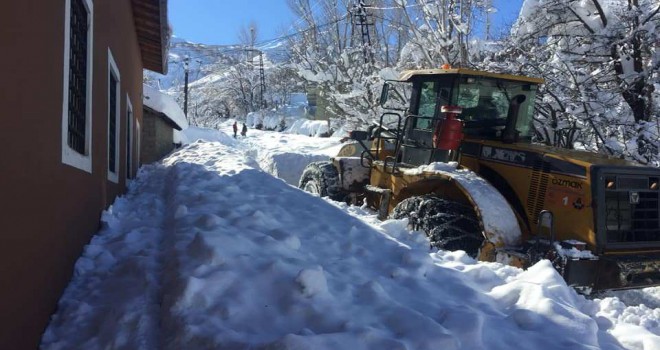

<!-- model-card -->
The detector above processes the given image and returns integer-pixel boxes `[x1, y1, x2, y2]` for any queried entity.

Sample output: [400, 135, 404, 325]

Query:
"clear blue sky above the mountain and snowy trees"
[173, 0, 523, 45]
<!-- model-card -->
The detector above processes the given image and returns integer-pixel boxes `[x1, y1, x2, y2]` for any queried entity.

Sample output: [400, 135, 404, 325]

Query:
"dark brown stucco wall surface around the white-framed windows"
[0, 0, 142, 349]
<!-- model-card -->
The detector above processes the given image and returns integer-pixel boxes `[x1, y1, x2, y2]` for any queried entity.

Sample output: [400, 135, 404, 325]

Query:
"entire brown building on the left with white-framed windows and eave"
[0, 0, 169, 349]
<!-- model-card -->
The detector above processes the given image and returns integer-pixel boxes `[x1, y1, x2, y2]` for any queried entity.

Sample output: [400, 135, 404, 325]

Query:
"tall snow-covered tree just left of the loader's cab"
[289, 0, 382, 124]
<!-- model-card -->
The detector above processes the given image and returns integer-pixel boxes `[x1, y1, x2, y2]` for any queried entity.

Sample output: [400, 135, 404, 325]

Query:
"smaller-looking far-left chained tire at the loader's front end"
[298, 161, 346, 201]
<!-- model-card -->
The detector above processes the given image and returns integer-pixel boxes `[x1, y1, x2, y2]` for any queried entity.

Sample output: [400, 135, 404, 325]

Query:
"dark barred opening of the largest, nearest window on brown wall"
[67, 0, 89, 155]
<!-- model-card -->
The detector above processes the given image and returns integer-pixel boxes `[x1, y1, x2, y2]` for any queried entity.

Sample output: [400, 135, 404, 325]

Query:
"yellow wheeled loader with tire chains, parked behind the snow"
[300, 67, 660, 293]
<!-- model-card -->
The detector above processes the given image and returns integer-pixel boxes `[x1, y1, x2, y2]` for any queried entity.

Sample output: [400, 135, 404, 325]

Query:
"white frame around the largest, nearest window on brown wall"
[62, 0, 94, 173]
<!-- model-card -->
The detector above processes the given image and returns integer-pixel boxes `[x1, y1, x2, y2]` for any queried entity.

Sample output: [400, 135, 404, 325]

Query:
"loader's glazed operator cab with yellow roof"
[390, 68, 543, 165]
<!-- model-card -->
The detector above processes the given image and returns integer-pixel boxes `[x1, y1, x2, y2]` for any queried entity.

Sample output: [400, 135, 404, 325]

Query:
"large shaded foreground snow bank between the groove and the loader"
[162, 142, 612, 349]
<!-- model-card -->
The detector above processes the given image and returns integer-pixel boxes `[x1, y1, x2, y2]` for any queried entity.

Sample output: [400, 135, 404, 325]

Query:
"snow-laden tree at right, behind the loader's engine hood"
[500, 0, 660, 164]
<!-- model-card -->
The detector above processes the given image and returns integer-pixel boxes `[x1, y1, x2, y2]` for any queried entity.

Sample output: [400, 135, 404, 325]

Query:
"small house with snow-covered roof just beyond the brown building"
[140, 85, 188, 164]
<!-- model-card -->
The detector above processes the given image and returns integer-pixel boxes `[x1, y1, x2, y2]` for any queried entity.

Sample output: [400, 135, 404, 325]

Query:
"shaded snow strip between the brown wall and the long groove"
[41, 164, 169, 349]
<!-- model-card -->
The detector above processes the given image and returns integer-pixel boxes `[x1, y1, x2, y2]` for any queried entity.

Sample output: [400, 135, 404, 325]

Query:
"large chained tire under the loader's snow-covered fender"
[390, 195, 484, 258]
